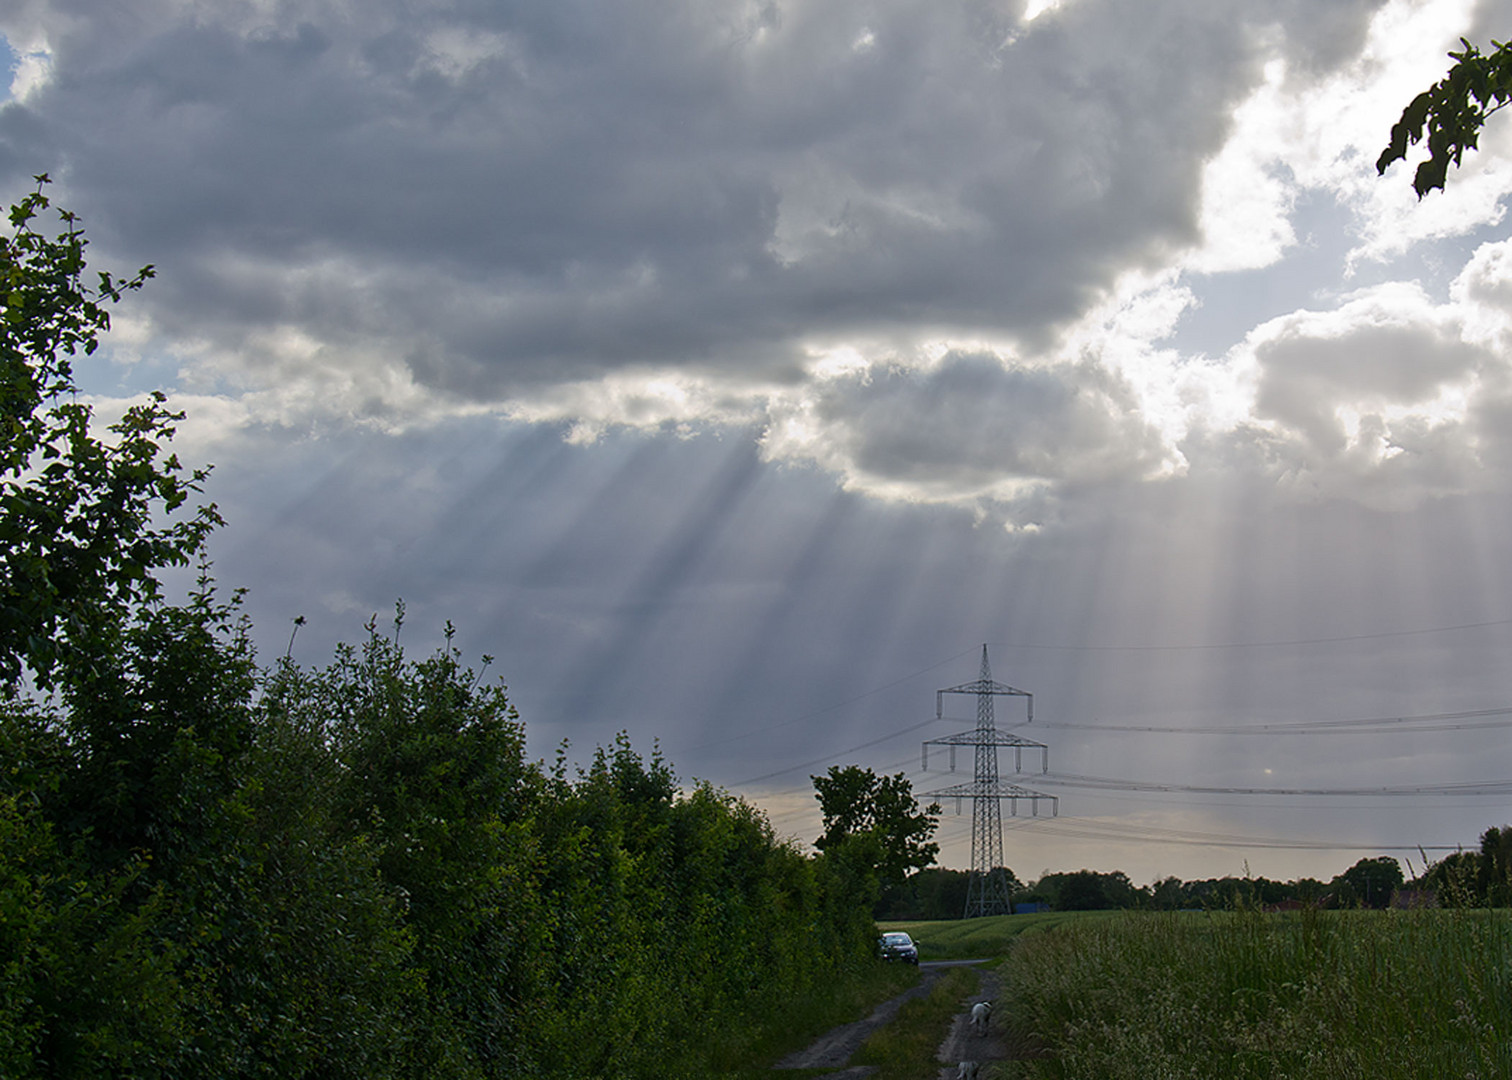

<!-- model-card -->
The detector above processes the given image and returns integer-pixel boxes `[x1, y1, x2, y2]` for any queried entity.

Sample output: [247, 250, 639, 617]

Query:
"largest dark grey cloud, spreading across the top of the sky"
[0, 0, 1368, 401]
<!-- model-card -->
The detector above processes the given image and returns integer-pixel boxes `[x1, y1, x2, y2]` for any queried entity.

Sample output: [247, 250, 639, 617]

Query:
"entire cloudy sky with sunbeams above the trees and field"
[0, 0, 1512, 883]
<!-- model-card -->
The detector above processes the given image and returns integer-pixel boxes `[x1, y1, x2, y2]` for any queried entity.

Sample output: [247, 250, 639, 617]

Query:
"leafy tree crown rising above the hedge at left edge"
[0, 174, 219, 688]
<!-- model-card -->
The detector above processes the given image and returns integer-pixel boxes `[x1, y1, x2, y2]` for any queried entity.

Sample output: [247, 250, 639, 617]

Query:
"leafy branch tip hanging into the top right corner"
[1376, 38, 1512, 198]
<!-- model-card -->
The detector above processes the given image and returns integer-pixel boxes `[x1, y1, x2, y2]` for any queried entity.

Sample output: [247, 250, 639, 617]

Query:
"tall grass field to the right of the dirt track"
[996, 911, 1512, 1080]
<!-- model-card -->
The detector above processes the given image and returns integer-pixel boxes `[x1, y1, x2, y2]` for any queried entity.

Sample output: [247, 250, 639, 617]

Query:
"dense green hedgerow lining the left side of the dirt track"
[0, 605, 875, 1080]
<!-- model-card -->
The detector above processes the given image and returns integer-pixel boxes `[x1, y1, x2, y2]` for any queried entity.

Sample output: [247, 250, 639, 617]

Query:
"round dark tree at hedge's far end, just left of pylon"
[809, 765, 940, 882]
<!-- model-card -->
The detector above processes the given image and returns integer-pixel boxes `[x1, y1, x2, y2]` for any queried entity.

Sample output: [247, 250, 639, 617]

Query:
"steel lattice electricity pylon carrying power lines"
[924, 646, 1060, 918]
